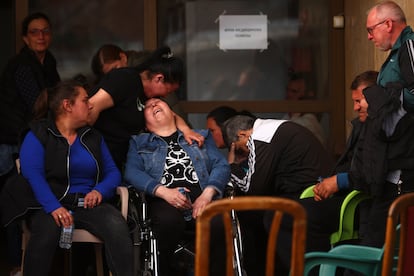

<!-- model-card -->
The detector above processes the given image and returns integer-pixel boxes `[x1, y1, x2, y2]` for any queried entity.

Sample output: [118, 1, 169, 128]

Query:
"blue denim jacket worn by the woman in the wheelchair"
[125, 130, 230, 197]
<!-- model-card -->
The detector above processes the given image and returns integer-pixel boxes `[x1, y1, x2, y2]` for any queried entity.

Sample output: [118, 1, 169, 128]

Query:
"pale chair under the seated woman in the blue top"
[21, 186, 129, 276]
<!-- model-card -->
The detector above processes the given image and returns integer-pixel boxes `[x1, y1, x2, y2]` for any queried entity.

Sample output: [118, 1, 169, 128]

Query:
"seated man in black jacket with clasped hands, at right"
[314, 70, 414, 251]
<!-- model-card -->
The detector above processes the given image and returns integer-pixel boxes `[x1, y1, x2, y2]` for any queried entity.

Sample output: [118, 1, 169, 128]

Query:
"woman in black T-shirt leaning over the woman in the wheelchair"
[89, 47, 204, 171]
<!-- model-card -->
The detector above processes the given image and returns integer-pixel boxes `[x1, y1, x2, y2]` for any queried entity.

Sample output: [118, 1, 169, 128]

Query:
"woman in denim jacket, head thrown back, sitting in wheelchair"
[125, 99, 230, 276]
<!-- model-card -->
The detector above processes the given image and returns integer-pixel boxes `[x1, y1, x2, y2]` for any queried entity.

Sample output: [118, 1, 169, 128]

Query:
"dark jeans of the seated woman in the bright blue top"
[24, 203, 133, 276]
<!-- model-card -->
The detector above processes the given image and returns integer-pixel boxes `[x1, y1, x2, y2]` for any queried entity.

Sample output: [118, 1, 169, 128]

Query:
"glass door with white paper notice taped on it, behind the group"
[157, 0, 343, 153]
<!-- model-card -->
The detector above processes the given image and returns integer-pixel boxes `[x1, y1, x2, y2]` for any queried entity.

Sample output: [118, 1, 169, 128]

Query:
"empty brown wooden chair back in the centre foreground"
[195, 196, 306, 276]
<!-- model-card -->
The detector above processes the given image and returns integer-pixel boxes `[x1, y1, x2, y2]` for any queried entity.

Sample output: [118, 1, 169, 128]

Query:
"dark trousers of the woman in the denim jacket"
[147, 198, 226, 276]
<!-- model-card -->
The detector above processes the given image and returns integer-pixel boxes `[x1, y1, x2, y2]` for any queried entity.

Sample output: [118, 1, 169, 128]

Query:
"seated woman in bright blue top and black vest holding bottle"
[1, 81, 133, 276]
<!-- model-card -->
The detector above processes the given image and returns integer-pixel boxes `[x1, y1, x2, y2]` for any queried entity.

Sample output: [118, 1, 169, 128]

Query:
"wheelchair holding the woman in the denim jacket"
[128, 183, 247, 276]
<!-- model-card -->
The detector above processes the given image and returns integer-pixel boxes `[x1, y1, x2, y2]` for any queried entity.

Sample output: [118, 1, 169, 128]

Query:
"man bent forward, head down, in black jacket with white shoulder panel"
[223, 116, 343, 275]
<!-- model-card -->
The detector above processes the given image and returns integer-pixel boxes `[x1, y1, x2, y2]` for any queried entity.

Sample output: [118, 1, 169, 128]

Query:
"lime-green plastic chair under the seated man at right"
[300, 185, 369, 246]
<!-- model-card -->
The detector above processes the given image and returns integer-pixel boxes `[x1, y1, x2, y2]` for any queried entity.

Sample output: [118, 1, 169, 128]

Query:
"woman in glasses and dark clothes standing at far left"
[0, 12, 60, 274]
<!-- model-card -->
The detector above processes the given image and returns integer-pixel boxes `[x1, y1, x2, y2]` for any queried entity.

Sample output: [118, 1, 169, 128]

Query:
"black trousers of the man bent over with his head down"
[238, 196, 345, 275]
